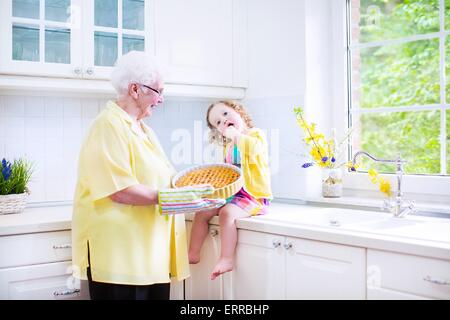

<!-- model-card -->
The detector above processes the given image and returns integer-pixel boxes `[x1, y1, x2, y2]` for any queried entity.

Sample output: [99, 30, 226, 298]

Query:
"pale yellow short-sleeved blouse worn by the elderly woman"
[72, 101, 189, 285]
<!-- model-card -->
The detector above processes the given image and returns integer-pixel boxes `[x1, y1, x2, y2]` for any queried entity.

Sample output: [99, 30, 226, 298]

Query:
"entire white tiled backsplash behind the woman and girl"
[0, 96, 312, 202]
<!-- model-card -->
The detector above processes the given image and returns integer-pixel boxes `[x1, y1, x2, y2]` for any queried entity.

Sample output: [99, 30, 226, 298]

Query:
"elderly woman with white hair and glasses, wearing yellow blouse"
[72, 51, 223, 299]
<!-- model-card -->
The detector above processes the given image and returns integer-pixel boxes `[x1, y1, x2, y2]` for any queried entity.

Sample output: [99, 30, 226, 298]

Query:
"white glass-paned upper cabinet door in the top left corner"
[0, 0, 82, 76]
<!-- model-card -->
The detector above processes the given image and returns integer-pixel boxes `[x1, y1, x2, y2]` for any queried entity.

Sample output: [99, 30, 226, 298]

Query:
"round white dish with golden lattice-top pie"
[172, 163, 244, 199]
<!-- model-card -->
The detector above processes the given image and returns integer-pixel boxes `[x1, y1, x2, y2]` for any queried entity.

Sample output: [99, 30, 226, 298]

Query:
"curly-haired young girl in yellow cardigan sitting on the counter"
[189, 101, 272, 280]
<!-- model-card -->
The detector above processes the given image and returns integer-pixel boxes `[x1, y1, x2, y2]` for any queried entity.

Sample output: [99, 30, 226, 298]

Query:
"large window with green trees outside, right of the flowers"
[347, 0, 450, 175]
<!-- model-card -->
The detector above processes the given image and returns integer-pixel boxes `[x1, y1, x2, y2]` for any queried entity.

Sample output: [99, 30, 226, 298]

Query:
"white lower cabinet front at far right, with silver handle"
[367, 249, 450, 300]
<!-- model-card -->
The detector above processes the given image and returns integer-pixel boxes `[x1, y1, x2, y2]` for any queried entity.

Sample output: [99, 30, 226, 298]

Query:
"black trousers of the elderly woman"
[87, 244, 170, 300]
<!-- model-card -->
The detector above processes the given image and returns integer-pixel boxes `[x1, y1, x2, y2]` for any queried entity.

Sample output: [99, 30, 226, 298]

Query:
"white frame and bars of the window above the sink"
[330, 0, 450, 202]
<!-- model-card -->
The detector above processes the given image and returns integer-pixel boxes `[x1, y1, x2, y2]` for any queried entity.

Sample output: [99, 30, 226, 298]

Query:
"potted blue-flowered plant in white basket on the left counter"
[0, 158, 32, 214]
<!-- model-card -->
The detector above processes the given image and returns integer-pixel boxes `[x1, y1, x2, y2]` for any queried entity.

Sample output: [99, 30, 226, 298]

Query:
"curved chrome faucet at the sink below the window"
[352, 151, 416, 218]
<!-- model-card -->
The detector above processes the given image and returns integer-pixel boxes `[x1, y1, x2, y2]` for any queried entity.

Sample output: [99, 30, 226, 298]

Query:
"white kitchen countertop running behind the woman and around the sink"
[0, 202, 450, 260]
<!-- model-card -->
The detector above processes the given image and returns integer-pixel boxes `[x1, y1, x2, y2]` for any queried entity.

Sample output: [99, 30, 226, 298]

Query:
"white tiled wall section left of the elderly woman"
[0, 96, 108, 202]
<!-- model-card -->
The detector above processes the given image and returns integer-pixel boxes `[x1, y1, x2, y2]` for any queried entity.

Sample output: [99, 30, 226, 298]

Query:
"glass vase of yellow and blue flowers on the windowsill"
[294, 107, 352, 198]
